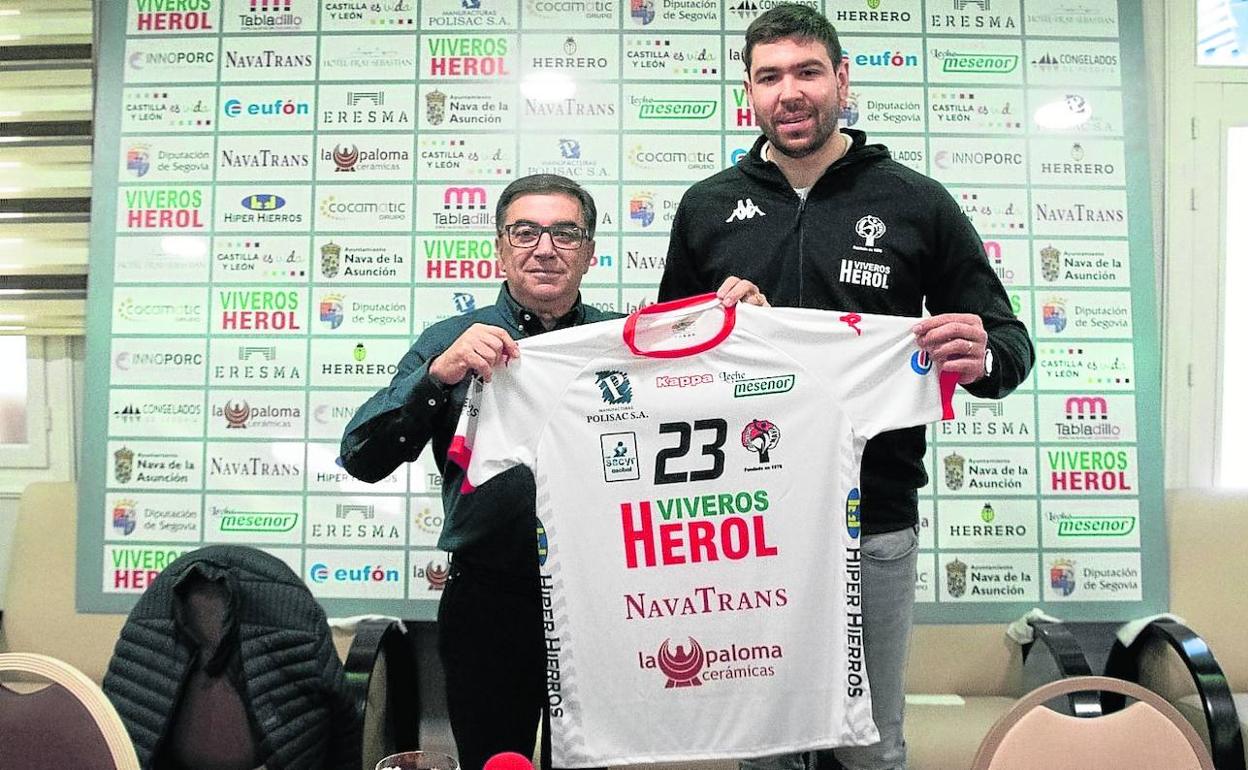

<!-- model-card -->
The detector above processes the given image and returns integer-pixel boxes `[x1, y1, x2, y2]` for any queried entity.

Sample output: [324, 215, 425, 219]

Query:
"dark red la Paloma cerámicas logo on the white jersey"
[636, 636, 784, 689]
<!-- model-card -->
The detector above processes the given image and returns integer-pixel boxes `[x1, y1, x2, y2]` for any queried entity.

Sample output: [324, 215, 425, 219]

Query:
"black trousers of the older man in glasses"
[438, 564, 601, 770]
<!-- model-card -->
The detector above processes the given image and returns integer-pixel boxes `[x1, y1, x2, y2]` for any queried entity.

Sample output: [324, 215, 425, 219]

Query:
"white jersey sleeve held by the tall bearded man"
[746, 308, 957, 438]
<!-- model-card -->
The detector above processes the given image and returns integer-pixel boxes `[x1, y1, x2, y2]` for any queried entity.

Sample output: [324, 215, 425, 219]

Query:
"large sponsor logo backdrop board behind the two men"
[77, 0, 1167, 621]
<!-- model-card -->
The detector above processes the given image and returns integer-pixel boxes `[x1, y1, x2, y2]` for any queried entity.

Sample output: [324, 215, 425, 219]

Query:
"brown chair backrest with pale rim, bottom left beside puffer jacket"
[0, 653, 139, 770]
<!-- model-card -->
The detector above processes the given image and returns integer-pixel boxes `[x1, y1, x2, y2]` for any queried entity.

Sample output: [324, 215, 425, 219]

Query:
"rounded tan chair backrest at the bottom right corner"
[971, 676, 1214, 770]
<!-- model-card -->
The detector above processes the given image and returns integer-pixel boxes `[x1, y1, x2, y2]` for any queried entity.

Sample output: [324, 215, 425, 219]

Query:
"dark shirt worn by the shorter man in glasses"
[341, 283, 620, 577]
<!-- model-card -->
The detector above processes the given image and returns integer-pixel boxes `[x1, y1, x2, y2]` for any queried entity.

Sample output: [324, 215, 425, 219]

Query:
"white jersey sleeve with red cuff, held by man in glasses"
[447, 354, 549, 493]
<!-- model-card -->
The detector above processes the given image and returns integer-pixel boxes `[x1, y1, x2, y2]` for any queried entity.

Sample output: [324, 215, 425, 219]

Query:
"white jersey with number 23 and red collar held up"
[452, 295, 952, 768]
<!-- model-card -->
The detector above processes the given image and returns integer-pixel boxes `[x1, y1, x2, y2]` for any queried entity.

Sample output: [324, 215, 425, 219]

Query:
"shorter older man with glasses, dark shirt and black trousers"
[342, 173, 619, 770]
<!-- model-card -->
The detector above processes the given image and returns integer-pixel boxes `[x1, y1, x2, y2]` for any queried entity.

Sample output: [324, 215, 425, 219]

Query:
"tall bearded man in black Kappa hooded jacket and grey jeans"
[659, 4, 1035, 770]
